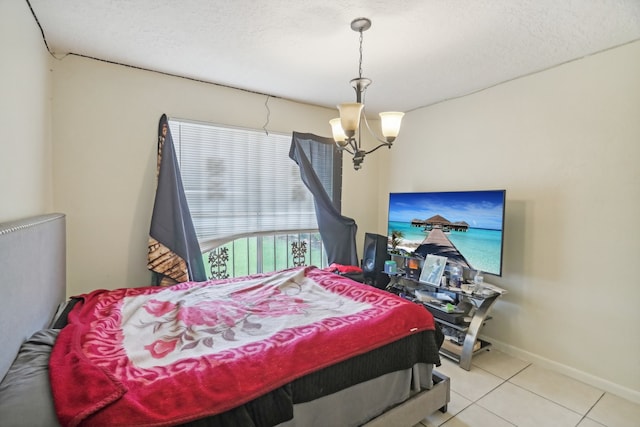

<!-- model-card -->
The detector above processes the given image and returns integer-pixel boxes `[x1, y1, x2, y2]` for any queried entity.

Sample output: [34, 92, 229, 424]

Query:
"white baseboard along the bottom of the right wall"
[483, 337, 640, 404]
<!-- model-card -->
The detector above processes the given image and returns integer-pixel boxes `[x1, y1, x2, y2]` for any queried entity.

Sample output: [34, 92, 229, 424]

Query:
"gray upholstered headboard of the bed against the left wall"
[0, 214, 66, 379]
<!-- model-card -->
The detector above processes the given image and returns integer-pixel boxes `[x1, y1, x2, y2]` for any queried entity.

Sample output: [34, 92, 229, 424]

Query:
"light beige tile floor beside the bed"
[414, 349, 640, 427]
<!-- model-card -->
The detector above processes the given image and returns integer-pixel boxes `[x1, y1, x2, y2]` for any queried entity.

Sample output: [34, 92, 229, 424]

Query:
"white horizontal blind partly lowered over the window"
[169, 119, 333, 250]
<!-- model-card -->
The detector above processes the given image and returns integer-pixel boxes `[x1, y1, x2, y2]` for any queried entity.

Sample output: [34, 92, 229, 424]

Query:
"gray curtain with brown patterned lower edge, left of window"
[147, 114, 207, 286]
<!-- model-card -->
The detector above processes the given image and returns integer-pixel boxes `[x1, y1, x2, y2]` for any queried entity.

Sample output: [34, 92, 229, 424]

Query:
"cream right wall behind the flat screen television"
[378, 42, 640, 401]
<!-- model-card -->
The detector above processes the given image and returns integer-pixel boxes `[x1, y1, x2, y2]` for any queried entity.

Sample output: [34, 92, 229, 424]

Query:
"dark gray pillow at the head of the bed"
[0, 329, 60, 427]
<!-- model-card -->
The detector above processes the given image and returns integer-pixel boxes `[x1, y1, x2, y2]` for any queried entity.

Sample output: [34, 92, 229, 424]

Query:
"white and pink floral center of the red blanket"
[84, 269, 379, 376]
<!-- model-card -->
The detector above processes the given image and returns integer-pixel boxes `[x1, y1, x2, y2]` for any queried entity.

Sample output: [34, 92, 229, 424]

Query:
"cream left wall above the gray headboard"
[0, 1, 52, 222]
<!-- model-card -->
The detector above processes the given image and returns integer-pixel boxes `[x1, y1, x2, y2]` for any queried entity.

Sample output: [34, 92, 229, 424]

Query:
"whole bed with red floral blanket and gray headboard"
[0, 214, 449, 427]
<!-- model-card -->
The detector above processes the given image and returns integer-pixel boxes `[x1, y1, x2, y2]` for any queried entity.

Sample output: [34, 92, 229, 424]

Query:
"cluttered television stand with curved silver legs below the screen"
[387, 272, 506, 371]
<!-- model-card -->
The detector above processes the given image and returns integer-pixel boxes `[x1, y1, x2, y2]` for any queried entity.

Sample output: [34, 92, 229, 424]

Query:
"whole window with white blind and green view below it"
[169, 120, 342, 278]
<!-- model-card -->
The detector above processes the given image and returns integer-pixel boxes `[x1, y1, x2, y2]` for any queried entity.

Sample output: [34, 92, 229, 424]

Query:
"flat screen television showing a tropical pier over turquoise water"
[387, 190, 506, 276]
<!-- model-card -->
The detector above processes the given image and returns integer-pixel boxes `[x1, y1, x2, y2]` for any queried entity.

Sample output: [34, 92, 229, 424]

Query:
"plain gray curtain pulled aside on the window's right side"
[289, 132, 358, 266]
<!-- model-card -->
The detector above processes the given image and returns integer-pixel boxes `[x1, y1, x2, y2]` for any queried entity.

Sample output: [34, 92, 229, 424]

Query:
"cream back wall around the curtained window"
[53, 56, 378, 294]
